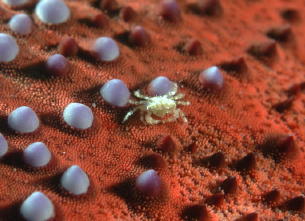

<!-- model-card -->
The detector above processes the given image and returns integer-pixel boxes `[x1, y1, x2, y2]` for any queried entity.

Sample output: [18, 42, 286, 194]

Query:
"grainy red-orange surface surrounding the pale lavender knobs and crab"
[0, 0, 305, 221]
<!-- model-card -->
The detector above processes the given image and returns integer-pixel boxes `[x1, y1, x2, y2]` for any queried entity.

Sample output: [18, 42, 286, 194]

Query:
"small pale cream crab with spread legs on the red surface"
[123, 83, 190, 124]
